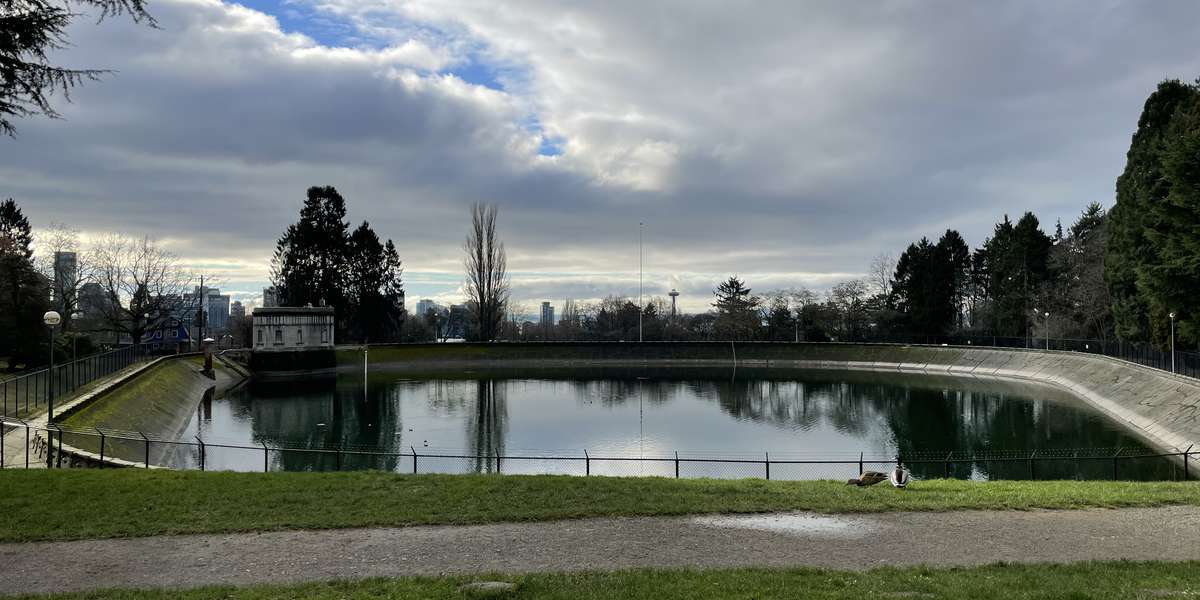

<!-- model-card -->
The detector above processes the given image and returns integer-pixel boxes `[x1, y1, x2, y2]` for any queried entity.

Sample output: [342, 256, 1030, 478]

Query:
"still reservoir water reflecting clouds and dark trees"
[174, 368, 1145, 478]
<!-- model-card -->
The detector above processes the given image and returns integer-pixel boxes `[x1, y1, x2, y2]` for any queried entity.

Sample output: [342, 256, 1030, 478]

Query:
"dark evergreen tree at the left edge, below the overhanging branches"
[0, 198, 49, 368]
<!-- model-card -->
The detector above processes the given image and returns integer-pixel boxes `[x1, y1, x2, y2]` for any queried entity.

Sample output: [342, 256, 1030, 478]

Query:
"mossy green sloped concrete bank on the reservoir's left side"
[56, 355, 244, 464]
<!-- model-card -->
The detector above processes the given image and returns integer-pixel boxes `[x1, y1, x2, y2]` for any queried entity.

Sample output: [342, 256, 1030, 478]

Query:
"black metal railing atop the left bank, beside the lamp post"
[0, 346, 157, 416]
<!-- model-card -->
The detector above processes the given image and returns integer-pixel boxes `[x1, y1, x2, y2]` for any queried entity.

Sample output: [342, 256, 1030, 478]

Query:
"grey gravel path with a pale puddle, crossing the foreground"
[0, 506, 1200, 594]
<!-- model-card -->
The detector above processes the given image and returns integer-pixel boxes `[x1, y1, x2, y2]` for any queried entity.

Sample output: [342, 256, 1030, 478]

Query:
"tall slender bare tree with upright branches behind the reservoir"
[463, 204, 509, 342]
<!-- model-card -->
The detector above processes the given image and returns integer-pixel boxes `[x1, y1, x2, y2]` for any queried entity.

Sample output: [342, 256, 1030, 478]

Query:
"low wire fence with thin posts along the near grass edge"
[0, 419, 1200, 481]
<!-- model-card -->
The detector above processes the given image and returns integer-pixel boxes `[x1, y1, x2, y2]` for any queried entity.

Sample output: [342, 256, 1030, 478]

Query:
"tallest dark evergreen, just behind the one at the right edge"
[1104, 79, 1198, 340]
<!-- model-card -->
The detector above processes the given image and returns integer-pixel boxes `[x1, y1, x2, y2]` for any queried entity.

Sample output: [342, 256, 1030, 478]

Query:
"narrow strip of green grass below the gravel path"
[14, 562, 1200, 600]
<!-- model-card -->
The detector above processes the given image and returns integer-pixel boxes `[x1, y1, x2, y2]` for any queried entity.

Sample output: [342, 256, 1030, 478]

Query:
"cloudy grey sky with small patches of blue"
[7, 0, 1200, 312]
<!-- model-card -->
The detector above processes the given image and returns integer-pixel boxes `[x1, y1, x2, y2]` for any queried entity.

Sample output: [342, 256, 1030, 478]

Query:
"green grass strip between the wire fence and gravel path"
[0, 469, 1200, 541]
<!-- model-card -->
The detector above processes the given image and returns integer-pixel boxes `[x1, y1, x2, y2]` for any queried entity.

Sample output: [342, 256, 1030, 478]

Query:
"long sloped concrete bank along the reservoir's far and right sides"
[338, 342, 1200, 451]
